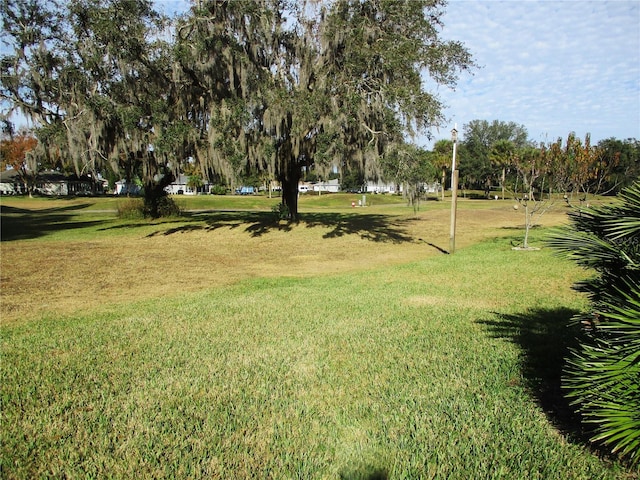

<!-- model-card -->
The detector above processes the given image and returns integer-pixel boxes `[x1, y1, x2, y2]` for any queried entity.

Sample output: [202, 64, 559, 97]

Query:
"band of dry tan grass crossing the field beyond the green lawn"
[0, 201, 565, 322]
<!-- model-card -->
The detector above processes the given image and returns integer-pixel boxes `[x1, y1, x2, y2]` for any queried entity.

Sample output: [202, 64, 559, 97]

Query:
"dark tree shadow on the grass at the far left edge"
[0, 203, 102, 242]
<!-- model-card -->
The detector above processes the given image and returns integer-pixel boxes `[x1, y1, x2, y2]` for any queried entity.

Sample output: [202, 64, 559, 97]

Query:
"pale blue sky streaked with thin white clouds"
[156, 0, 640, 148]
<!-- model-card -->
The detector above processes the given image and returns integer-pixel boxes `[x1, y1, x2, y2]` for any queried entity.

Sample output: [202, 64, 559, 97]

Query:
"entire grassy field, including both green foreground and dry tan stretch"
[0, 195, 637, 479]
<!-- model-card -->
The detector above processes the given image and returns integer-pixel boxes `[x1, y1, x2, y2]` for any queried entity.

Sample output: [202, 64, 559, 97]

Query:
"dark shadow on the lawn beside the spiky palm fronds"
[478, 308, 588, 444]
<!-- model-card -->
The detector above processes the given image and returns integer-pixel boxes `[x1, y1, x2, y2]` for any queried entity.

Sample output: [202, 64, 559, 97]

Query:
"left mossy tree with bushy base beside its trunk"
[0, 0, 183, 216]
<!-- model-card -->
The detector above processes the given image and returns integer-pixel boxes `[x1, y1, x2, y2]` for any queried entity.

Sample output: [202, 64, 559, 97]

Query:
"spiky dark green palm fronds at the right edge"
[550, 182, 640, 464]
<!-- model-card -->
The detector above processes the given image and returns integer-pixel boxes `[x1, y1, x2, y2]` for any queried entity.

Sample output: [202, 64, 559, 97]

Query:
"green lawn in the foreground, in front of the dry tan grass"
[0, 197, 637, 479]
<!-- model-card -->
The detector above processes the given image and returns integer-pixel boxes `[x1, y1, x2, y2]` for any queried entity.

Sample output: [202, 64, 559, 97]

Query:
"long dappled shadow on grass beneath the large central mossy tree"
[143, 211, 438, 248]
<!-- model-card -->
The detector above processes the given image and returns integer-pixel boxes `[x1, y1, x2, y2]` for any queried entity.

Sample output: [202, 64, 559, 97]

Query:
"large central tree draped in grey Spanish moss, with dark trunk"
[177, 0, 473, 219]
